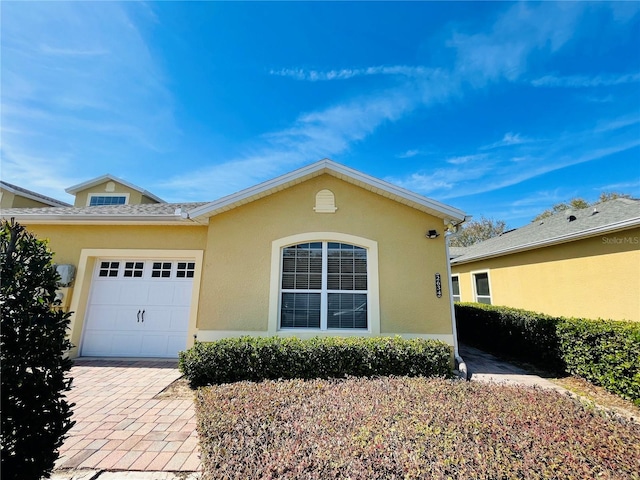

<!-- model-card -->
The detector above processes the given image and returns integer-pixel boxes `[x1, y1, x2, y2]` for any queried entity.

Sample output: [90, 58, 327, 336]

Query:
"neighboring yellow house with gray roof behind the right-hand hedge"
[450, 198, 640, 321]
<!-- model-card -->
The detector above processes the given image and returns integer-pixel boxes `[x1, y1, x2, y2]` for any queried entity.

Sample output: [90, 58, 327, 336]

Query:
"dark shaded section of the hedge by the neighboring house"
[455, 303, 565, 372]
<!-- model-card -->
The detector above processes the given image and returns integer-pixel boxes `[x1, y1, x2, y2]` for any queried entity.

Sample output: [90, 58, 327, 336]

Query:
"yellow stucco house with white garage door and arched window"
[3, 160, 465, 357]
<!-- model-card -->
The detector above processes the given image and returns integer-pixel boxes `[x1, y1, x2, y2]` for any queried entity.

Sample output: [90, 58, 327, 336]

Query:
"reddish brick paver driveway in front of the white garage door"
[56, 359, 200, 472]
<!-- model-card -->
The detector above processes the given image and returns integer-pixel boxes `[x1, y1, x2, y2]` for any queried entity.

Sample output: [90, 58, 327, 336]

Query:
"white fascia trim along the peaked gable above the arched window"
[189, 159, 465, 220]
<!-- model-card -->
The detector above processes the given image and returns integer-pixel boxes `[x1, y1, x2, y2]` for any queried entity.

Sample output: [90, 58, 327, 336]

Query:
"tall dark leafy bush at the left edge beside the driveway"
[0, 221, 74, 479]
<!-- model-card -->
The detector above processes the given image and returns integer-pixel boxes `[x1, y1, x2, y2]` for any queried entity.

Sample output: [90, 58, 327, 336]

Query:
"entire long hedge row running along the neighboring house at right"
[455, 303, 640, 405]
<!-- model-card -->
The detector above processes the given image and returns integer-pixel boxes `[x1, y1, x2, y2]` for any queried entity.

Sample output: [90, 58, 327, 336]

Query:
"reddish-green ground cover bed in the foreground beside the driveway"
[196, 377, 640, 479]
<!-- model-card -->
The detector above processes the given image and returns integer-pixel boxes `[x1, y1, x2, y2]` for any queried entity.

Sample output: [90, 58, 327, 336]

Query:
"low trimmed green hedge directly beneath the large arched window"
[179, 337, 451, 388]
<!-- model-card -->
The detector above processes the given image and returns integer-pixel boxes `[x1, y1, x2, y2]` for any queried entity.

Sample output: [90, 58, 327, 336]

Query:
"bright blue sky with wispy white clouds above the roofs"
[0, 1, 640, 227]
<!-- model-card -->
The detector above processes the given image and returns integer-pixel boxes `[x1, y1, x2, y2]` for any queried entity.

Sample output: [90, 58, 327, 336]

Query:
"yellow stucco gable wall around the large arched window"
[199, 175, 452, 335]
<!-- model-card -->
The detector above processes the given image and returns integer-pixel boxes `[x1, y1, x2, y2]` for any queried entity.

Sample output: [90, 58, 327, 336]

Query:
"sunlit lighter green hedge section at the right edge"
[558, 318, 640, 406]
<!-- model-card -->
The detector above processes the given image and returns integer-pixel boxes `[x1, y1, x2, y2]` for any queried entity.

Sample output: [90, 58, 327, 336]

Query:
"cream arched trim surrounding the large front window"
[268, 232, 380, 338]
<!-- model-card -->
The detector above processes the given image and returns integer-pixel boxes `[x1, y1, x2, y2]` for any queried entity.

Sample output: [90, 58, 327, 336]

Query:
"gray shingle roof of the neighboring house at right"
[451, 198, 640, 265]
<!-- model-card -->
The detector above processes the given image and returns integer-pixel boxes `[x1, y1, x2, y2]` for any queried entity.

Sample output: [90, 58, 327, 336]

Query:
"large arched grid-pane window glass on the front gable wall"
[280, 242, 368, 330]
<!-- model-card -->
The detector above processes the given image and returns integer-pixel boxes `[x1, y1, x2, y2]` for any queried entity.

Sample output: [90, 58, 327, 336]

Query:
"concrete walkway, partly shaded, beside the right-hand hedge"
[458, 344, 567, 392]
